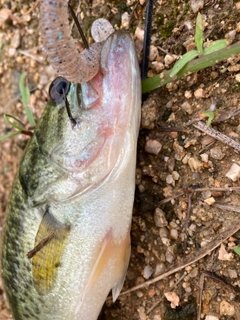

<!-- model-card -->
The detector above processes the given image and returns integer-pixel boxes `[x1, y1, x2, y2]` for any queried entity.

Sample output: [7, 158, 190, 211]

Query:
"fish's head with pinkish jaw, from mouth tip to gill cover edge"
[23, 31, 141, 203]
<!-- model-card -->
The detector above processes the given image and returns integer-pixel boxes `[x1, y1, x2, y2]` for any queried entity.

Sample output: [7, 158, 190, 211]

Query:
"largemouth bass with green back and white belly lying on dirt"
[2, 31, 141, 320]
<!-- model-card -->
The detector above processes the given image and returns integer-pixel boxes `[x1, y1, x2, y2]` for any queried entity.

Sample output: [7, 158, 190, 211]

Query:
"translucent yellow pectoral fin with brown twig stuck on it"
[29, 209, 70, 293]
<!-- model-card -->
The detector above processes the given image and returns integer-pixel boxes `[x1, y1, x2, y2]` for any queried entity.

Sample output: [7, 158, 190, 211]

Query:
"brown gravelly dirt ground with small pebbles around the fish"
[0, 0, 240, 320]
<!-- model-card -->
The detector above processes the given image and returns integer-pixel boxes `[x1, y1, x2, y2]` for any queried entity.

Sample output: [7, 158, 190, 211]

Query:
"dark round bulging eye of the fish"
[49, 77, 71, 102]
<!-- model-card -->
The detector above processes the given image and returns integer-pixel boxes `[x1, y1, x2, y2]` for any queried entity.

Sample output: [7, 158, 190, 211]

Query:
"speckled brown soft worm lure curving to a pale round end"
[40, 0, 114, 83]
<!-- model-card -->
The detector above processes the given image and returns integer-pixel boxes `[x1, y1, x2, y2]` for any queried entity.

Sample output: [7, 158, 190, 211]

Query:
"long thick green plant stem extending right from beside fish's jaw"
[142, 42, 240, 93]
